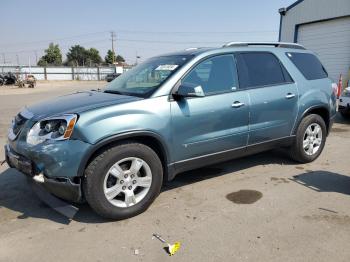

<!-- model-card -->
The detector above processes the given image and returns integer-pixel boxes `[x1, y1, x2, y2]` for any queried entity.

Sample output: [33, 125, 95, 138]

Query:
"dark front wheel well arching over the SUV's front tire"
[83, 135, 168, 181]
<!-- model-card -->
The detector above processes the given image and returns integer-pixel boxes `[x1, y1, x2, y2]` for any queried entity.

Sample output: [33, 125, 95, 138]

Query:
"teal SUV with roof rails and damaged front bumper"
[5, 42, 336, 219]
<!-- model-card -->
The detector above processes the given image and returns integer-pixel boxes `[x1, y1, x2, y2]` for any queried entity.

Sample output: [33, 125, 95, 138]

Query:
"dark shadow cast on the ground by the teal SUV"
[0, 150, 295, 224]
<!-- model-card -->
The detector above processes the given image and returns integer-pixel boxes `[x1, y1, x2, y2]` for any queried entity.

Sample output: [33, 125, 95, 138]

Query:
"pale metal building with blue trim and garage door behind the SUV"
[279, 0, 350, 80]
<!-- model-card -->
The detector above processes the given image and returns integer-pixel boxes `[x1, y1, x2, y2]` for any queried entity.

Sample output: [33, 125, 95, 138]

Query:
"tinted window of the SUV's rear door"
[237, 52, 293, 88]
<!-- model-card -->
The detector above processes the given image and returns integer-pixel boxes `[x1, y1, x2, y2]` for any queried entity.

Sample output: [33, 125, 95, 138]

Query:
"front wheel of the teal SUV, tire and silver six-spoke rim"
[83, 141, 163, 220]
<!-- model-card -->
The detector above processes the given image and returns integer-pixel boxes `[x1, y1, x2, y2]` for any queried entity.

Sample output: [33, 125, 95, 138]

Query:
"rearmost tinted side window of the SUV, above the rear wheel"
[287, 53, 328, 80]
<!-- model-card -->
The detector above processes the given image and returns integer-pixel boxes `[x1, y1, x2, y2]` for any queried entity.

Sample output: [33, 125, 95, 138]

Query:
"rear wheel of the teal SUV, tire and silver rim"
[290, 114, 327, 163]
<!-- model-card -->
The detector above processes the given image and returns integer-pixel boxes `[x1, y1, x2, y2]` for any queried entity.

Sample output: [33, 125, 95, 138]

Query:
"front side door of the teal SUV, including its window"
[171, 54, 249, 162]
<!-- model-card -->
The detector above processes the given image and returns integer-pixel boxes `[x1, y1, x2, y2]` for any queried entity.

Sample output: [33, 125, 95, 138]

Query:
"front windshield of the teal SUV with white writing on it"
[104, 55, 192, 97]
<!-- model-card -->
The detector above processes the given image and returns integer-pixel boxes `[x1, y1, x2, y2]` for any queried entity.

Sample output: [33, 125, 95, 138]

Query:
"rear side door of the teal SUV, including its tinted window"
[237, 52, 298, 145]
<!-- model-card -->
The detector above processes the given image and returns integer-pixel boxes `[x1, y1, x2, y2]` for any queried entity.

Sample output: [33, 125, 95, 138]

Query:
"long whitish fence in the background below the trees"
[0, 65, 126, 80]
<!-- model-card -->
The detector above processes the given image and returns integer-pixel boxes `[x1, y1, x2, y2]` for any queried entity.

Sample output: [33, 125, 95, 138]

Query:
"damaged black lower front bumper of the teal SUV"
[5, 145, 83, 202]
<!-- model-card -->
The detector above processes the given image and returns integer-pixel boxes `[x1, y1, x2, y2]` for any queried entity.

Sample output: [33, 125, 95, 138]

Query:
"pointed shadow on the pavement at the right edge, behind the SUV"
[290, 170, 350, 195]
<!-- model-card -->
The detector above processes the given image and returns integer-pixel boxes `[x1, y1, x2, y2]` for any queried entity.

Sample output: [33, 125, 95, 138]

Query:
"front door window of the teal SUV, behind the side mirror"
[182, 55, 237, 95]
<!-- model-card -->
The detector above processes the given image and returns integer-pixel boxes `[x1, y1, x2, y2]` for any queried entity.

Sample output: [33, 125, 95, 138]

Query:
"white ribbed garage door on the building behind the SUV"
[298, 17, 350, 81]
